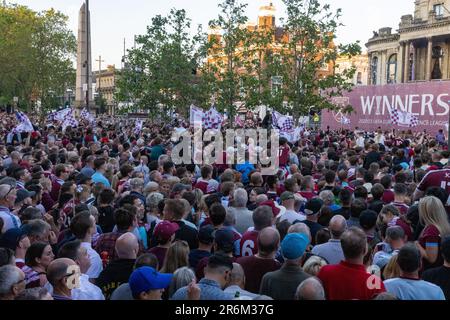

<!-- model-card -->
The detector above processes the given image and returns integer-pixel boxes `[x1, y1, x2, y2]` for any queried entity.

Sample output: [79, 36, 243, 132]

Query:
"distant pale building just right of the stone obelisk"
[94, 65, 120, 115]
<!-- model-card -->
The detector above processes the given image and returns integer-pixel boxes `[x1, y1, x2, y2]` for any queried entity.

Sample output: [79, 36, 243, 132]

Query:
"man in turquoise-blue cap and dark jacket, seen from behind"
[259, 233, 310, 300]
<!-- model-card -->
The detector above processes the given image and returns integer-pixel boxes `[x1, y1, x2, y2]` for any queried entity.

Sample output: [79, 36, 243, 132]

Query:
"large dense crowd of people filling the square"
[0, 112, 450, 300]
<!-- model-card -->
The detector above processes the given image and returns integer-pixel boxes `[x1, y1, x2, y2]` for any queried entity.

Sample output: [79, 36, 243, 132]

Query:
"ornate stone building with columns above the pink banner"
[366, 0, 450, 85]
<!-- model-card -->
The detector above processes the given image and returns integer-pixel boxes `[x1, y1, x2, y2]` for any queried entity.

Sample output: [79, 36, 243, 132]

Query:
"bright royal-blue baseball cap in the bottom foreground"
[128, 267, 172, 296]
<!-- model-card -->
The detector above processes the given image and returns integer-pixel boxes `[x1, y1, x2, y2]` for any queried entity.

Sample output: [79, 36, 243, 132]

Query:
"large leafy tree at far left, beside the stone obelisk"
[0, 5, 76, 109]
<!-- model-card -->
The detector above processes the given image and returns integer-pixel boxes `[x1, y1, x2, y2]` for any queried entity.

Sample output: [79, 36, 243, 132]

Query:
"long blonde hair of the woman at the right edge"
[419, 196, 450, 237]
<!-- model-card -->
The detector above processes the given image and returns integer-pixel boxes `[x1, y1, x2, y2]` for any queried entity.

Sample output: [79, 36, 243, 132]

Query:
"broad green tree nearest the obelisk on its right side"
[116, 9, 208, 117]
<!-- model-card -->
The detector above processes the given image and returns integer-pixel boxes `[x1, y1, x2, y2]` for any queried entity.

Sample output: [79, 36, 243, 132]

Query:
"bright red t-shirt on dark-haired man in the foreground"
[317, 261, 386, 300]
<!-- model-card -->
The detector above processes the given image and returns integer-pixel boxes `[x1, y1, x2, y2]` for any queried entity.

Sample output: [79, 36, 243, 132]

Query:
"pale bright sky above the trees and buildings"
[7, 0, 414, 70]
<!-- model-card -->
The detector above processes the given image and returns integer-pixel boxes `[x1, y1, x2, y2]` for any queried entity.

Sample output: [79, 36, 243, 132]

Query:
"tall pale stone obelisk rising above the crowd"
[75, 0, 94, 114]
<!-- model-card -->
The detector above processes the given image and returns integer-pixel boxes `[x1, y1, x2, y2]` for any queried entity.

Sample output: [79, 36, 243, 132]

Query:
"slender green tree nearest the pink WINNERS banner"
[282, 0, 361, 118]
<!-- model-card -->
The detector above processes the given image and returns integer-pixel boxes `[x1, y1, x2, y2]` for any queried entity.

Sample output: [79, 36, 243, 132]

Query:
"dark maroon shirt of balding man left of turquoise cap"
[236, 256, 281, 293]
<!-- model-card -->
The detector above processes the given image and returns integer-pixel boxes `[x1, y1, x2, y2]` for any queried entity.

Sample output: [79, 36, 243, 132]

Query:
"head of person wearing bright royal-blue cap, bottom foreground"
[128, 267, 172, 300]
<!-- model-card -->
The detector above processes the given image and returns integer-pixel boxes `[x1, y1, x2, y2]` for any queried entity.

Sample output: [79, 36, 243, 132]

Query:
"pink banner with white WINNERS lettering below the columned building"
[322, 81, 450, 133]
